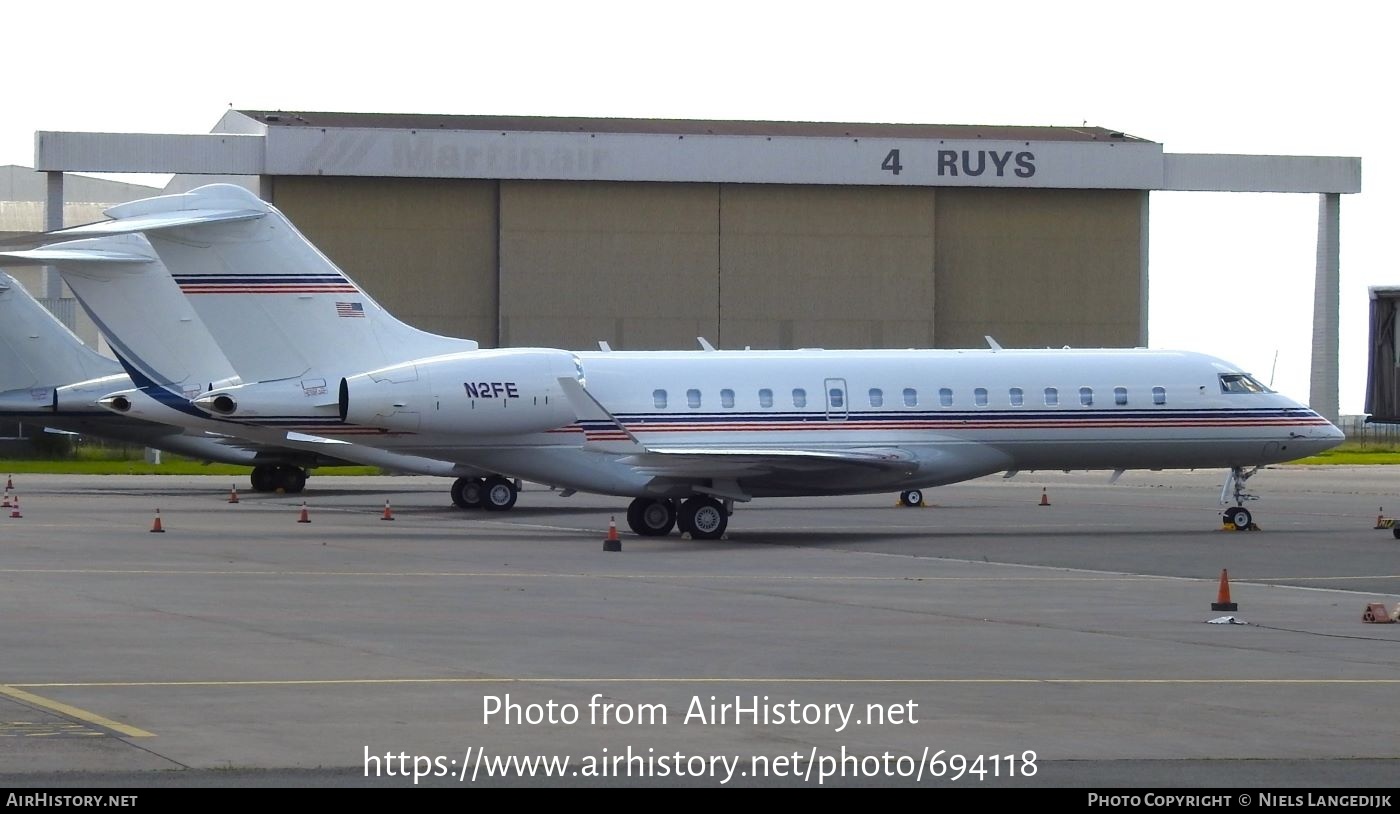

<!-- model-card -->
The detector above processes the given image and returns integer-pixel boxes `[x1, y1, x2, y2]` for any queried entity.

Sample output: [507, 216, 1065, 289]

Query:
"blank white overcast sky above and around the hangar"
[0, 0, 1400, 413]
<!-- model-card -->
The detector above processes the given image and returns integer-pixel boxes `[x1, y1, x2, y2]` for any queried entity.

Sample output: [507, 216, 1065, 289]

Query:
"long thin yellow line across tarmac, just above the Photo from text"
[10, 675, 1400, 686]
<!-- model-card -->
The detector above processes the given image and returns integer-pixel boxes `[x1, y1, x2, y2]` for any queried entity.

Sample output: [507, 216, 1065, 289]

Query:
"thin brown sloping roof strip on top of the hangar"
[238, 111, 1152, 143]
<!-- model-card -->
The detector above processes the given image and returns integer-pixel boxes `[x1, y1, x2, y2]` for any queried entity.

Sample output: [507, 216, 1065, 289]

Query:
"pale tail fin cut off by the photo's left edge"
[0, 270, 120, 392]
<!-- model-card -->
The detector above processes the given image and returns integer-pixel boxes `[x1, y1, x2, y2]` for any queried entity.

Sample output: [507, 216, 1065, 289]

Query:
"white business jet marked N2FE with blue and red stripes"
[19, 185, 1343, 538]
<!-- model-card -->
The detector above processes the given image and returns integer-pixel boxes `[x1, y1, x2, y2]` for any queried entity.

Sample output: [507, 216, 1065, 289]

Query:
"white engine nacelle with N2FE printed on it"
[340, 347, 580, 436]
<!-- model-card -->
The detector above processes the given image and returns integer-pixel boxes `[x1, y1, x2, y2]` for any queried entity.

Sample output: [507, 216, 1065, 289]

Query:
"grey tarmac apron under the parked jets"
[0, 467, 1400, 789]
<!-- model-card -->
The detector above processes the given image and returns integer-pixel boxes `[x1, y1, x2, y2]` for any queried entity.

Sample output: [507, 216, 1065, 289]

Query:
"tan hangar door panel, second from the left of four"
[500, 181, 720, 350]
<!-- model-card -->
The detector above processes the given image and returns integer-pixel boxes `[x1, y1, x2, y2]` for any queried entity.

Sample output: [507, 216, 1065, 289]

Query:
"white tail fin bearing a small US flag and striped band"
[79, 184, 477, 382]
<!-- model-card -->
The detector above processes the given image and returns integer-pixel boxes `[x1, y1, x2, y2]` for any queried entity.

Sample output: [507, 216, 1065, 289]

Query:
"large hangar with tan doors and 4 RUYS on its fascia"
[21, 111, 1361, 416]
